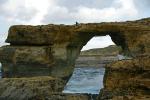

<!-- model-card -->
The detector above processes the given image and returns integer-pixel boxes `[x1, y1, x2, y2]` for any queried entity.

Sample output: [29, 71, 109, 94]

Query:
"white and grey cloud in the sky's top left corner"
[0, 0, 53, 25]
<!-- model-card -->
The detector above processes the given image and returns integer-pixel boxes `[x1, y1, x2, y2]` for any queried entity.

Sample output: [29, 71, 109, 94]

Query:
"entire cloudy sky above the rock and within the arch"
[0, 0, 150, 49]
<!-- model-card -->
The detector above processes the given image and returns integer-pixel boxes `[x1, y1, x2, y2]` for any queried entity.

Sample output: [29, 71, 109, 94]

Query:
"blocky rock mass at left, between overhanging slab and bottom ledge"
[0, 46, 53, 77]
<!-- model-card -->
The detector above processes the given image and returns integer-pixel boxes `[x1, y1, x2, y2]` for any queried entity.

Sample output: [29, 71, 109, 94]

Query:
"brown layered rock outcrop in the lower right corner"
[99, 55, 150, 100]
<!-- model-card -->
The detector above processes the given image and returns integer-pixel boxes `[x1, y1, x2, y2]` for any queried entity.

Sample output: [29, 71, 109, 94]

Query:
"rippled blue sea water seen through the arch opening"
[63, 67, 105, 94]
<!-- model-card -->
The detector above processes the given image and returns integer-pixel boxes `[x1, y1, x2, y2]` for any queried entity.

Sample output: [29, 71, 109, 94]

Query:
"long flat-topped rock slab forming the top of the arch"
[6, 18, 150, 45]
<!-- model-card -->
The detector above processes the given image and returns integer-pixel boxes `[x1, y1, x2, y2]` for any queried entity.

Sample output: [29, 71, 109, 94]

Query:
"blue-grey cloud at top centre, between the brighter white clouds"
[43, 0, 114, 24]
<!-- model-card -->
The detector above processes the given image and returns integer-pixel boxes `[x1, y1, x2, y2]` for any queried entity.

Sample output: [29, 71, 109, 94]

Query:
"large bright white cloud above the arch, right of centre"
[43, 0, 138, 23]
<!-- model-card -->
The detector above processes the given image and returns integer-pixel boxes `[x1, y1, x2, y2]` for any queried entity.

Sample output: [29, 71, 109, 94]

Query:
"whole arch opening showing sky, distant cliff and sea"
[63, 35, 121, 94]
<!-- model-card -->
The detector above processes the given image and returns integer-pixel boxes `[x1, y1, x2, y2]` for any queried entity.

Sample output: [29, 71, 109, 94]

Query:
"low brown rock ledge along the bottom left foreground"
[0, 76, 91, 100]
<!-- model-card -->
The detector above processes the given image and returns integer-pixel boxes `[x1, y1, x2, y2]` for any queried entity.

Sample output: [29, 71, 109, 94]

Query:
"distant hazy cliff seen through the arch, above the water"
[75, 45, 121, 67]
